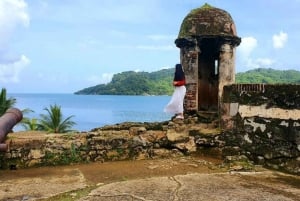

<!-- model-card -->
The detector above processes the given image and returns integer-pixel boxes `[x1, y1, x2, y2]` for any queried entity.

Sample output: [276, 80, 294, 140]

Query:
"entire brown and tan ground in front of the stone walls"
[0, 156, 300, 201]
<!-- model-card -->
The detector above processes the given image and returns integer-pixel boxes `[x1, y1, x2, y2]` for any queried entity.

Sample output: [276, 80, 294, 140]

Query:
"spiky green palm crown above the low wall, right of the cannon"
[40, 104, 76, 133]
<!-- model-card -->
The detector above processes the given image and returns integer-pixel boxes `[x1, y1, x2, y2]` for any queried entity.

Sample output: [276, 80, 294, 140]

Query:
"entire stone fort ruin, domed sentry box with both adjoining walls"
[0, 4, 300, 175]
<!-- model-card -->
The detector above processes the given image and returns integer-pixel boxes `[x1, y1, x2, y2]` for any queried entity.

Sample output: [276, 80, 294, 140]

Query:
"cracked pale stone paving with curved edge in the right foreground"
[80, 172, 300, 201]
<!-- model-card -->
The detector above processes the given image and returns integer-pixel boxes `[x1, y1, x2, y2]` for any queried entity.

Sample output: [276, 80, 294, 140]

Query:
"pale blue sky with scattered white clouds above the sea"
[0, 0, 300, 93]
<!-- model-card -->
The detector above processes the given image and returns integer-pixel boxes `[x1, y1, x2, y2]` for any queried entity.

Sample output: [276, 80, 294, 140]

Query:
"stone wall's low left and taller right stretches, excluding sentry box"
[0, 84, 300, 175]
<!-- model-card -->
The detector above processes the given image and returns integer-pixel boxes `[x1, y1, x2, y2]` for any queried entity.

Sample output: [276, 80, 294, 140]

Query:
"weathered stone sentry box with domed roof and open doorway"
[175, 4, 241, 112]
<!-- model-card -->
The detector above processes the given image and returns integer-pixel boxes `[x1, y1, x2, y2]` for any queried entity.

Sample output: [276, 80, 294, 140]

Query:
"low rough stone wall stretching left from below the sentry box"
[0, 116, 224, 169]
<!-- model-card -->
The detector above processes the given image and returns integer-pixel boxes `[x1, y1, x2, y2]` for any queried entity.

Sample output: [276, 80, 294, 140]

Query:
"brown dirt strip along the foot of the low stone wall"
[0, 157, 222, 200]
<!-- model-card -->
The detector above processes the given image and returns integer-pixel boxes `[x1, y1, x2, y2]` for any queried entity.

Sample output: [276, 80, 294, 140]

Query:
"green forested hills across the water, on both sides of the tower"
[75, 68, 300, 95]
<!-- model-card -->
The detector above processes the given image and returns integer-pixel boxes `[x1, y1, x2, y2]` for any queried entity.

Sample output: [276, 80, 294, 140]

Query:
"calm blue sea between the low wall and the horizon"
[7, 94, 171, 131]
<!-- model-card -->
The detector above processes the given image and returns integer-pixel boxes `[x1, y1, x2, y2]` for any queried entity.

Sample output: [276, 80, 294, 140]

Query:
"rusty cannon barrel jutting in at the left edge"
[0, 108, 23, 143]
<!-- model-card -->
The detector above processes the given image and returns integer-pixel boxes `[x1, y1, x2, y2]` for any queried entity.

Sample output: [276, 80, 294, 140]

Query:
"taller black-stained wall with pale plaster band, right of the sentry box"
[221, 84, 300, 173]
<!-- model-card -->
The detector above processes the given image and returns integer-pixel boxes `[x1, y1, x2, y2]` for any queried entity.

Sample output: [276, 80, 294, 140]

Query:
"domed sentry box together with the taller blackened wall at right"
[175, 4, 300, 173]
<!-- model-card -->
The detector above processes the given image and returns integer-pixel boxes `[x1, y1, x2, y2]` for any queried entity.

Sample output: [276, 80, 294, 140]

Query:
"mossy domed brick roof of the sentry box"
[178, 3, 240, 45]
